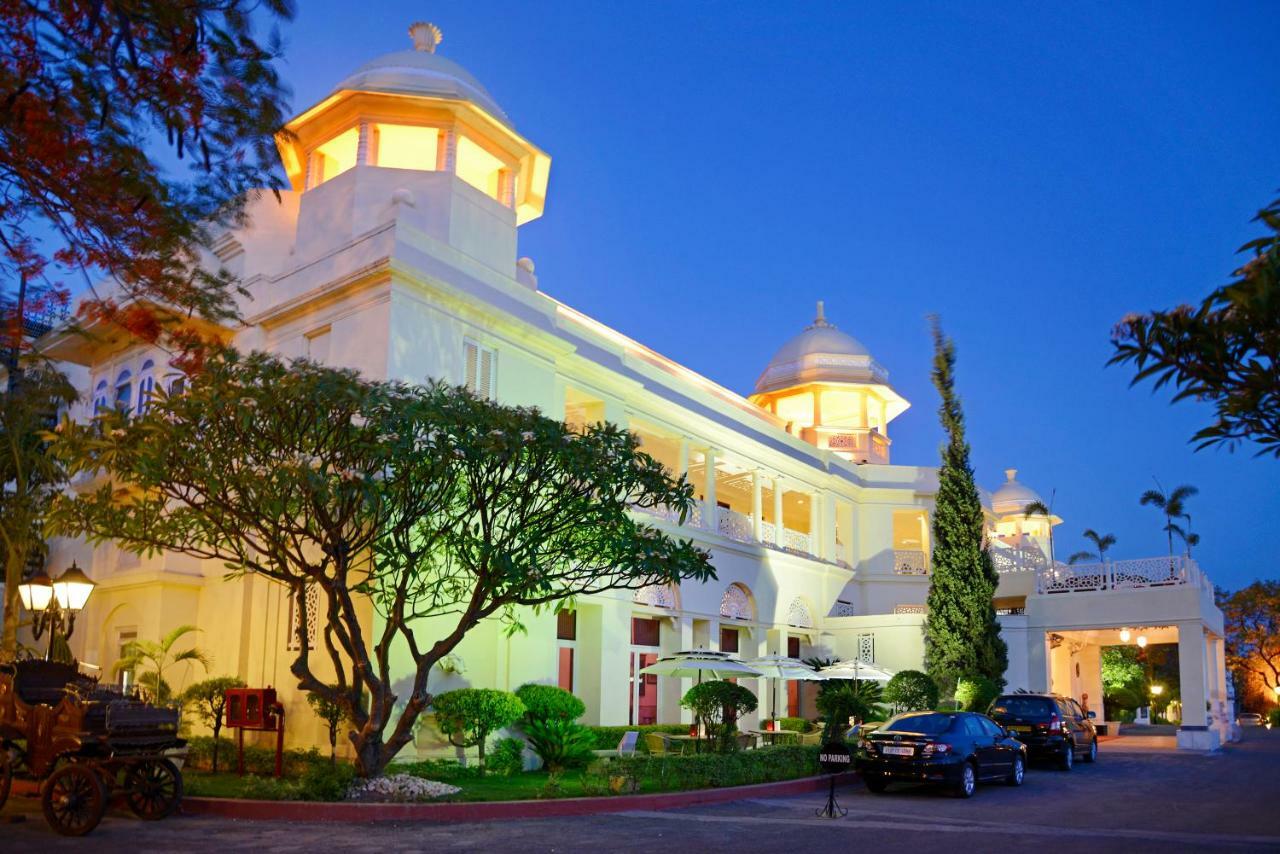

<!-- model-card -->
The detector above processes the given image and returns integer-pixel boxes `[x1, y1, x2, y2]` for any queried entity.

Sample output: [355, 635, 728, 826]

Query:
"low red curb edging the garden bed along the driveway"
[182, 772, 856, 822]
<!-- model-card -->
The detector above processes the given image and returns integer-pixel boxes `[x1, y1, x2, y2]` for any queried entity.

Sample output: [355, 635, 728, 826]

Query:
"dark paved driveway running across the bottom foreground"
[0, 730, 1280, 854]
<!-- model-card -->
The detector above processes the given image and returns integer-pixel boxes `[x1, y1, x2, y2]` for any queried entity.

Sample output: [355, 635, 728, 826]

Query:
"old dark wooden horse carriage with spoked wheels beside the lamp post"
[0, 661, 186, 836]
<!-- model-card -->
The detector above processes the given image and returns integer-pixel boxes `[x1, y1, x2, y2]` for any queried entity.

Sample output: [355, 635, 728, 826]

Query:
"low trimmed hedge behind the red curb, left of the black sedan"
[600, 745, 820, 790]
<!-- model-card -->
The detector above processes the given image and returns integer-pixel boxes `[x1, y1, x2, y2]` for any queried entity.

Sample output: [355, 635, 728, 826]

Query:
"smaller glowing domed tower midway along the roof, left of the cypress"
[751, 301, 910, 463]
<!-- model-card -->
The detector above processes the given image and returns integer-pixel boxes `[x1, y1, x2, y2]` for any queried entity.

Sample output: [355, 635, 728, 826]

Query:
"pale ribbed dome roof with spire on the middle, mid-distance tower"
[755, 302, 885, 396]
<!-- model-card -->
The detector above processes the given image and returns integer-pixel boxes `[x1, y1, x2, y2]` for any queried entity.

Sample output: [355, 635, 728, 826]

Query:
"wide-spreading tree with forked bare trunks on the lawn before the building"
[54, 352, 714, 776]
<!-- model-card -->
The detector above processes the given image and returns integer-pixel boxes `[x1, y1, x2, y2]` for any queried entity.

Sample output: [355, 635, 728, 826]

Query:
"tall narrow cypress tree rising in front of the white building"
[924, 318, 1009, 694]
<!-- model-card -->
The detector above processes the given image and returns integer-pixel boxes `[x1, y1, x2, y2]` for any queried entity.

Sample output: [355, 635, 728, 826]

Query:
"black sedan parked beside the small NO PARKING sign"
[855, 712, 1027, 798]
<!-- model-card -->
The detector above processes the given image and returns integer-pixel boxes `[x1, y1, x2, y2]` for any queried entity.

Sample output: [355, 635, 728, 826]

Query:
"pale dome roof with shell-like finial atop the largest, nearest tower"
[334, 23, 511, 125]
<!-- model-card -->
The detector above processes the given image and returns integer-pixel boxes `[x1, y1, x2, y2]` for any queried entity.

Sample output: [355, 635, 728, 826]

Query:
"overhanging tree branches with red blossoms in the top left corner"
[0, 0, 292, 361]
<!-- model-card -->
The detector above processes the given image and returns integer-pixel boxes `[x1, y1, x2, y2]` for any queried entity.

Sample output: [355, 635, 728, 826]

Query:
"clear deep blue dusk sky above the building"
[283, 0, 1280, 588]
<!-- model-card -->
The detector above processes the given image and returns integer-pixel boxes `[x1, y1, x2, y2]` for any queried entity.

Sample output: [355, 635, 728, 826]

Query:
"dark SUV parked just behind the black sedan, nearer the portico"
[987, 694, 1098, 771]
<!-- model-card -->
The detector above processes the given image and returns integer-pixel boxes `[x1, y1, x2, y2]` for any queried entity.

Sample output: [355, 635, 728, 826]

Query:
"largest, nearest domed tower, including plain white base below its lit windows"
[276, 23, 550, 277]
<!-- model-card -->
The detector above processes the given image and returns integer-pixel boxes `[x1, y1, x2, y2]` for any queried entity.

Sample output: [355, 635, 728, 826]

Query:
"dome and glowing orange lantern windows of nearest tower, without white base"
[276, 22, 550, 230]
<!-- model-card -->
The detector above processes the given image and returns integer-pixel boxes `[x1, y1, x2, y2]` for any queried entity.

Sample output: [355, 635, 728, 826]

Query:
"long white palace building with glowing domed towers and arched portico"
[35, 24, 1230, 750]
